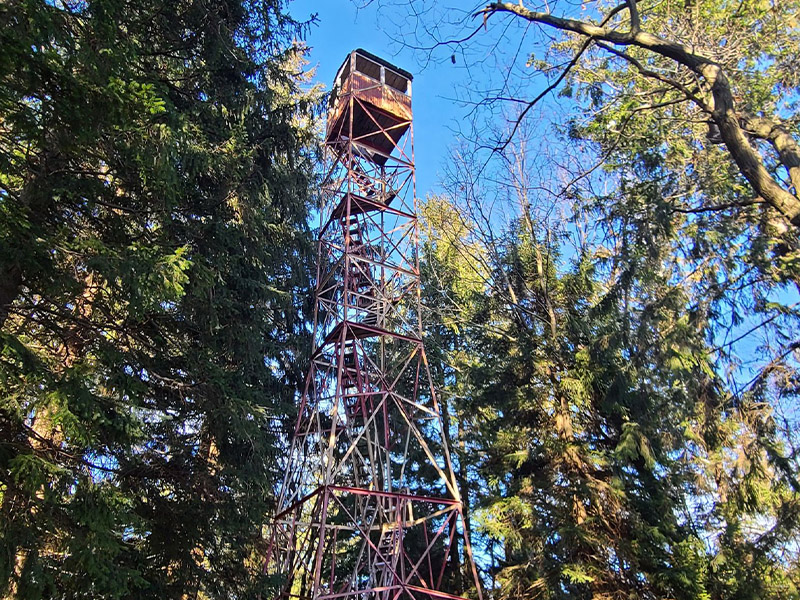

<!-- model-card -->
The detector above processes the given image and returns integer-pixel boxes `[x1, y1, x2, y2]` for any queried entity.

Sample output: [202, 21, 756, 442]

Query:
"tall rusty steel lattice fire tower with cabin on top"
[267, 50, 480, 600]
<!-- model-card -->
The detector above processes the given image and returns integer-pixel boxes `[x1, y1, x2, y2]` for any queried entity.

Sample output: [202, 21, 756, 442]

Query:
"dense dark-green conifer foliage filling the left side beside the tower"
[0, 0, 316, 599]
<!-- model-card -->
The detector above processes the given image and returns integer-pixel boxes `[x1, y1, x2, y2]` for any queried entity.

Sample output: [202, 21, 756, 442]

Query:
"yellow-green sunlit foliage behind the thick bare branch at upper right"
[546, 1, 800, 272]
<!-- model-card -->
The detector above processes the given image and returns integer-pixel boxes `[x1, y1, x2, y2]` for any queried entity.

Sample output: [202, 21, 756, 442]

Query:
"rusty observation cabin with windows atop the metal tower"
[325, 48, 413, 165]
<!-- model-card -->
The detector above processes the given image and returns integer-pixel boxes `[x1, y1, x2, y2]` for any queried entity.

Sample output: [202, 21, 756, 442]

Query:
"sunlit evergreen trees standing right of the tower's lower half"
[418, 157, 798, 598]
